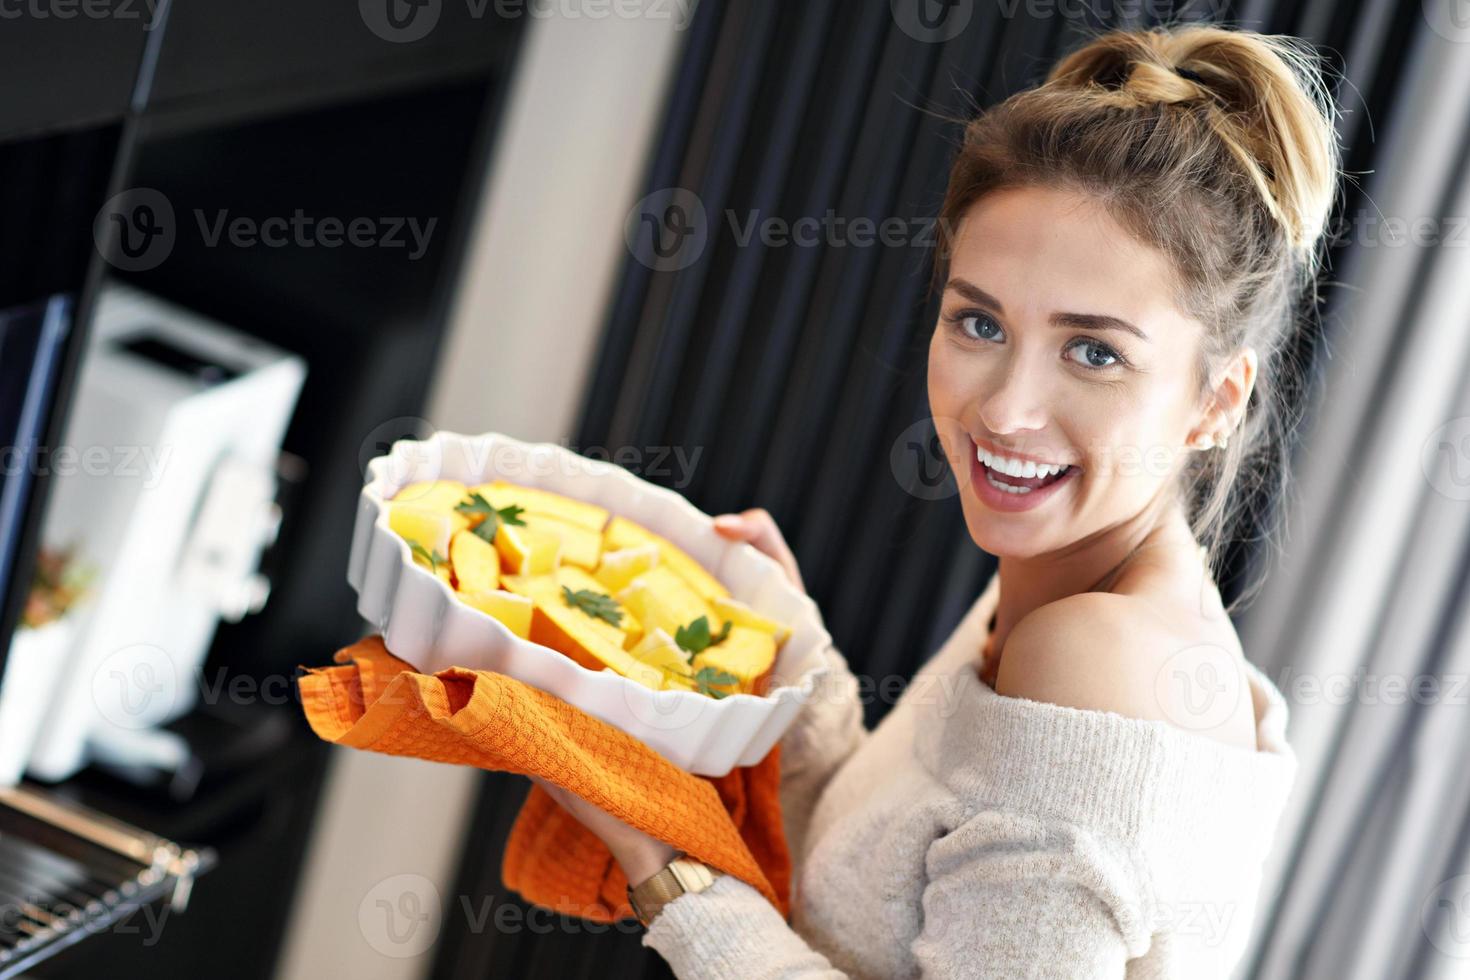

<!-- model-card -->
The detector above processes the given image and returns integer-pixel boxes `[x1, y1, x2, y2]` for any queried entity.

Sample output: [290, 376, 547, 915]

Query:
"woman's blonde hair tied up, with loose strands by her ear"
[933, 24, 1341, 608]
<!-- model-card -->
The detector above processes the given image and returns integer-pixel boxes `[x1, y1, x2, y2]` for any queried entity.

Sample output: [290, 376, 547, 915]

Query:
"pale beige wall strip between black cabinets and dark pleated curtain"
[276, 0, 685, 980]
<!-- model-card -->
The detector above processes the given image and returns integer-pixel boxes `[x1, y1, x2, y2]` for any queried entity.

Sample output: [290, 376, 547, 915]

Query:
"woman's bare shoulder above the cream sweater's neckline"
[995, 591, 1257, 749]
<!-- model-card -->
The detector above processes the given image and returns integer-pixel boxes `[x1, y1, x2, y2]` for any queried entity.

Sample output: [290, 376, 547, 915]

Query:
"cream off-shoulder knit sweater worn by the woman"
[642, 576, 1297, 980]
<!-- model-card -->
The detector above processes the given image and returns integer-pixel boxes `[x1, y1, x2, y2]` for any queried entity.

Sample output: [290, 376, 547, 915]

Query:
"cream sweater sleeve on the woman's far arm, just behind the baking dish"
[781, 646, 867, 861]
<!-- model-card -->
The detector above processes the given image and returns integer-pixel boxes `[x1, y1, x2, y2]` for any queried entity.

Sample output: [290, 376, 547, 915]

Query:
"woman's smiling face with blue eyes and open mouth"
[929, 188, 1228, 557]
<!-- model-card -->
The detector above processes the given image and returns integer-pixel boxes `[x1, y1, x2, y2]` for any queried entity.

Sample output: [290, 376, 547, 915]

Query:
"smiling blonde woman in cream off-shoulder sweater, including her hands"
[542, 25, 1338, 979]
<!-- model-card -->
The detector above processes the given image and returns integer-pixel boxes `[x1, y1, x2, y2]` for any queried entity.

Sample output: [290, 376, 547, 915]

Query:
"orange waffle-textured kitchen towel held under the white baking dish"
[297, 636, 791, 923]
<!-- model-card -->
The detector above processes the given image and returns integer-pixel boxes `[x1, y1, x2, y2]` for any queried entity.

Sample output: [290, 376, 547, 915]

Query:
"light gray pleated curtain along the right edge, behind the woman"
[1241, 15, 1470, 980]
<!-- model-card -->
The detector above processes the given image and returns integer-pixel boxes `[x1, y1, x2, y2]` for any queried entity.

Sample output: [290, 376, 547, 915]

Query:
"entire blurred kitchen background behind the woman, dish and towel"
[0, 0, 1470, 980]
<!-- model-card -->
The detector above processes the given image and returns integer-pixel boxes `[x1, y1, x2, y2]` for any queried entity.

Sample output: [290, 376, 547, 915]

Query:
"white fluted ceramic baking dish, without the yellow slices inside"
[347, 432, 832, 776]
